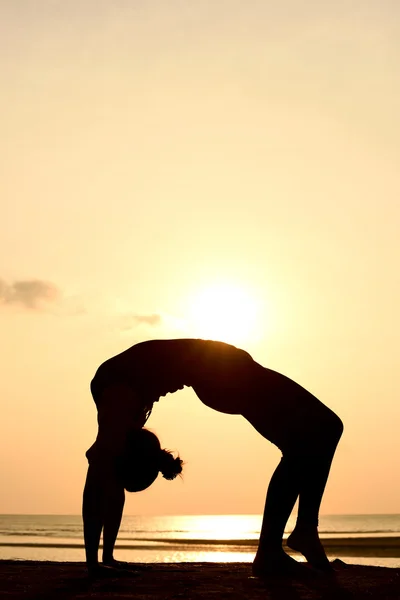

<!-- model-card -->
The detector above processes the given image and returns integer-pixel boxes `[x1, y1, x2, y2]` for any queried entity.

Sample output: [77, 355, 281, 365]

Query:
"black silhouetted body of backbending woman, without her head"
[83, 339, 343, 576]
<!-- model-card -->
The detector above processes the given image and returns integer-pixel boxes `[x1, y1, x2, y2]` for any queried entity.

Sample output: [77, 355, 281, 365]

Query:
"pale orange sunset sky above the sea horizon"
[0, 0, 400, 514]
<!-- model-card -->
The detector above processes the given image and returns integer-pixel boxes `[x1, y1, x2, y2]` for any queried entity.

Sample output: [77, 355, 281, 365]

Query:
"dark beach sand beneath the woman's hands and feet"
[0, 560, 400, 600]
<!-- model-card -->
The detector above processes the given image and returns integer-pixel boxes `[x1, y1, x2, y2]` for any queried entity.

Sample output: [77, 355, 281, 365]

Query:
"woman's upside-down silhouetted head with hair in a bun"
[117, 429, 183, 492]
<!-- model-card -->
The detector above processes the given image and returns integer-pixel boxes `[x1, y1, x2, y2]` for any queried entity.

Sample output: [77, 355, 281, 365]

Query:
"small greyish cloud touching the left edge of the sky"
[0, 279, 60, 310]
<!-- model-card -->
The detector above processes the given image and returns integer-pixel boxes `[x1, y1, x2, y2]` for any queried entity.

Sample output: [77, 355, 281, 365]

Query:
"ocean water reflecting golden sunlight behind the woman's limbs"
[0, 515, 400, 567]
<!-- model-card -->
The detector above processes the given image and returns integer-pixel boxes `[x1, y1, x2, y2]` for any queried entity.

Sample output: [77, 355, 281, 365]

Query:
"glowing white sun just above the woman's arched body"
[188, 283, 259, 344]
